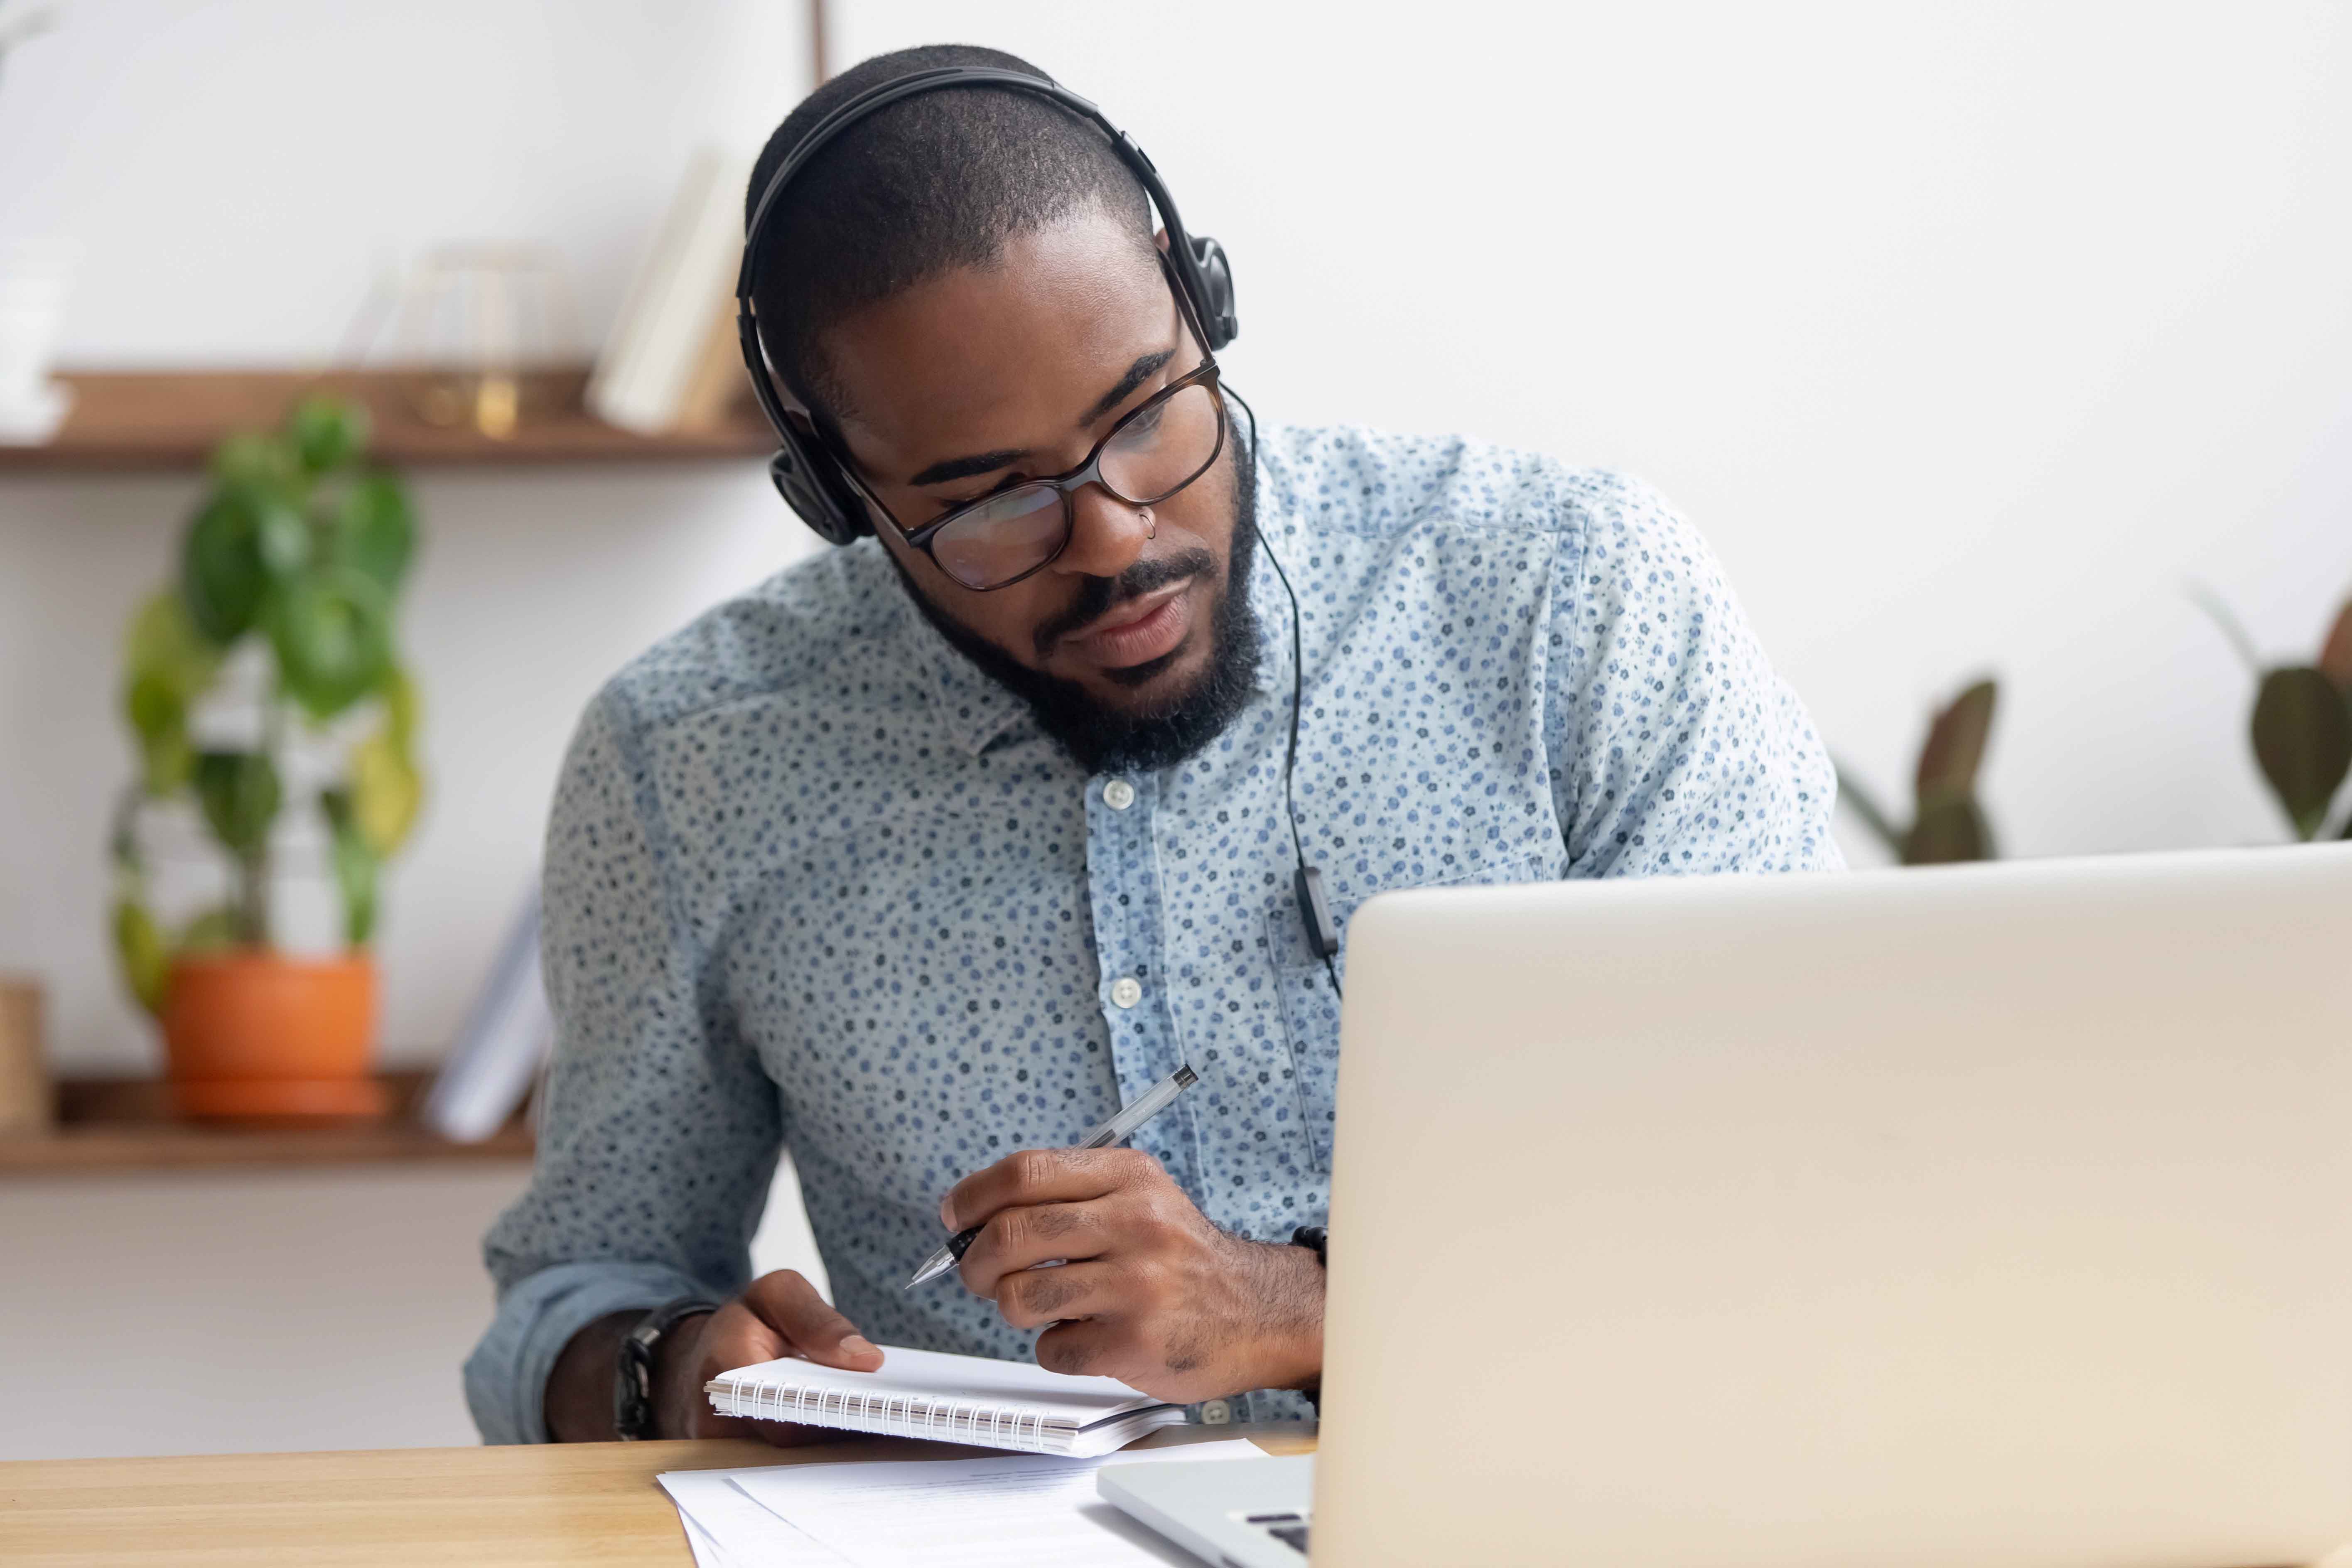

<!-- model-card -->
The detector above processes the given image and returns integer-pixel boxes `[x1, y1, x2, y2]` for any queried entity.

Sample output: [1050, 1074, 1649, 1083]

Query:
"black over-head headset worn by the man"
[736, 66, 1240, 545]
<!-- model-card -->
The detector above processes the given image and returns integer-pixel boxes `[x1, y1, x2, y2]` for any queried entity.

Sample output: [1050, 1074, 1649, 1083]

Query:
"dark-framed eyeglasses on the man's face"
[842, 359, 1225, 592]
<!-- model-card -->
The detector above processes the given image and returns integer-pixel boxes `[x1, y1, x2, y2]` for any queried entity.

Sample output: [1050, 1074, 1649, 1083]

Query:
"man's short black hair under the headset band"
[743, 45, 1152, 423]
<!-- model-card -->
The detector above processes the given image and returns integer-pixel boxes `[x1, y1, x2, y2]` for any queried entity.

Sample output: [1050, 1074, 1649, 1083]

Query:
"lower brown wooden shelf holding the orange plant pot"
[0, 1072, 532, 1178]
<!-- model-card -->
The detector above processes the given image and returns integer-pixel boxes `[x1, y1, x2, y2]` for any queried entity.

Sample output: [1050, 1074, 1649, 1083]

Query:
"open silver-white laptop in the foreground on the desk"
[1101, 846, 2352, 1568]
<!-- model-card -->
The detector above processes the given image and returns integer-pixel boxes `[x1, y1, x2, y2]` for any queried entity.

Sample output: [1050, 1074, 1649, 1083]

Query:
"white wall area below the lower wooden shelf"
[0, 1161, 825, 1460]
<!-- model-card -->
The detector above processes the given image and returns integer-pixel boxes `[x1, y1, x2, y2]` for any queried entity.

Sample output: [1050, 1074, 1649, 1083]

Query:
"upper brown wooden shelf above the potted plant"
[0, 367, 776, 475]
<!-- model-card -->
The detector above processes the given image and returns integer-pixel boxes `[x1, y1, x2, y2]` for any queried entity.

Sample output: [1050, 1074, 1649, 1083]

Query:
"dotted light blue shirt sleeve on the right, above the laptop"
[1545, 475, 1844, 877]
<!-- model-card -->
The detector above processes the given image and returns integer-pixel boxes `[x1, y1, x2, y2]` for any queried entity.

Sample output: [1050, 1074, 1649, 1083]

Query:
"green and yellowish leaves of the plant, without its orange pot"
[113, 397, 423, 1011]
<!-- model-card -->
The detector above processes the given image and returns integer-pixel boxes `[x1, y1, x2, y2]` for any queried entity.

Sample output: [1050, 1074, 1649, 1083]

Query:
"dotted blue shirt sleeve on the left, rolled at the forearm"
[466, 687, 781, 1443]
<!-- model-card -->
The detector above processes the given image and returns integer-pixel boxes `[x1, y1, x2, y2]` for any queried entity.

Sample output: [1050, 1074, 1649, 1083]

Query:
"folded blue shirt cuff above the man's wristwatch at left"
[466, 1262, 710, 1443]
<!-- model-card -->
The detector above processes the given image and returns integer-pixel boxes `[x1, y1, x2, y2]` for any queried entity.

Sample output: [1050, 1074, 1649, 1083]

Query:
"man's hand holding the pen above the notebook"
[938, 1150, 1324, 1404]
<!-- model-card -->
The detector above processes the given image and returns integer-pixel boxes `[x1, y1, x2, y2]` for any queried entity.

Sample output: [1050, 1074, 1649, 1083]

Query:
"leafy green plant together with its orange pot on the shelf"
[113, 397, 423, 1116]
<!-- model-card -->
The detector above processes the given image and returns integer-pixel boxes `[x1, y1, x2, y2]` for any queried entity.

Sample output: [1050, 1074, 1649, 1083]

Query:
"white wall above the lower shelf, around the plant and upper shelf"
[0, 0, 814, 1070]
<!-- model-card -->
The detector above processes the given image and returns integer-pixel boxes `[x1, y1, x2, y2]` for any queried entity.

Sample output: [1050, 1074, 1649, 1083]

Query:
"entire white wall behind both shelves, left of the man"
[0, 0, 821, 1458]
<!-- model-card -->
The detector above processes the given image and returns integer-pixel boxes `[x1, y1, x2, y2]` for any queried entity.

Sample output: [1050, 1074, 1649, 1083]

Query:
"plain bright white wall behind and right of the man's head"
[840, 0, 2352, 856]
